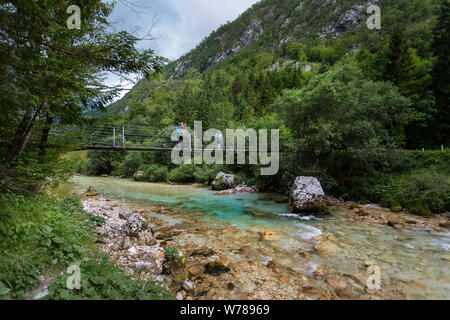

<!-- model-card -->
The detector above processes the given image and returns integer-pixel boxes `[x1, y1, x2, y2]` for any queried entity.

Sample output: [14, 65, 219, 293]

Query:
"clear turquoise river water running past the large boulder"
[74, 176, 450, 299]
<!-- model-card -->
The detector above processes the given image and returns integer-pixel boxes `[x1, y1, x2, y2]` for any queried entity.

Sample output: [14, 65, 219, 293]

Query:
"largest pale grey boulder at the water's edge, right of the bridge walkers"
[289, 177, 328, 214]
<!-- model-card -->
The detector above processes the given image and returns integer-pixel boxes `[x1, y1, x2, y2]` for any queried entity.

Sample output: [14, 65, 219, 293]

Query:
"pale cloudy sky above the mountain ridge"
[107, 0, 258, 97]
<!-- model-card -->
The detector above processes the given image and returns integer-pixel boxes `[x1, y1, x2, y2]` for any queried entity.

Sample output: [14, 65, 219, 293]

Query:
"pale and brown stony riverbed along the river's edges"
[79, 186, 449, 300]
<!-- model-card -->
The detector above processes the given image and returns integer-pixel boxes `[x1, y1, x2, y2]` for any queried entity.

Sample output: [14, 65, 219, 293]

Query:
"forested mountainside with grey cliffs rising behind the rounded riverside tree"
[110, 0, 445, 148]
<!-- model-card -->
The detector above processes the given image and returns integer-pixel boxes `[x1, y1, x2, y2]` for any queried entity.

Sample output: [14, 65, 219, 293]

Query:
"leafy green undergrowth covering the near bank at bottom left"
[0, 195, 170, 299]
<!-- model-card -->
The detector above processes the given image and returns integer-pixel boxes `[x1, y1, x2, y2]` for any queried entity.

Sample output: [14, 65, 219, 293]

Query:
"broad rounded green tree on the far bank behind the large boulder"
[275, 63, 410, 159]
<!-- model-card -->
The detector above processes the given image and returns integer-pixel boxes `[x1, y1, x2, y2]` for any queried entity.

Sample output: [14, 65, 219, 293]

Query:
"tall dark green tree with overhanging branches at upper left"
[0, 0, 163, 163]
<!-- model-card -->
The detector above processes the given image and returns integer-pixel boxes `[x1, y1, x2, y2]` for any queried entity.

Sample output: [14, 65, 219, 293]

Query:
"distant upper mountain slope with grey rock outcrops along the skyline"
[163, 0, 431, 78]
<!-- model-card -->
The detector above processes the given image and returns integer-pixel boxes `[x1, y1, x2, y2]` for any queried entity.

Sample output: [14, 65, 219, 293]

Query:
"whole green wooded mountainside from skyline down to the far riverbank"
[88, 0, 450, 212]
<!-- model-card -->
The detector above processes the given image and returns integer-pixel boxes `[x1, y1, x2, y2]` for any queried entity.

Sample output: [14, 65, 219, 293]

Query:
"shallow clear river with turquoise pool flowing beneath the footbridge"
[73, 176, 450, 299]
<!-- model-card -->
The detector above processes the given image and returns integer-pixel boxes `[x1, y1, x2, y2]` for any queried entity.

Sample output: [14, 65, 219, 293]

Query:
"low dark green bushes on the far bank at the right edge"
[341, 151, 450, 214]
